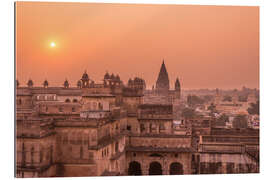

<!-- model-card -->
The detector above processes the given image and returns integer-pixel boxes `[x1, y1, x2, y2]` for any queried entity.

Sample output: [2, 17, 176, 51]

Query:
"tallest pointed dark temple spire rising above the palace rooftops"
[156, 60, 170, 92]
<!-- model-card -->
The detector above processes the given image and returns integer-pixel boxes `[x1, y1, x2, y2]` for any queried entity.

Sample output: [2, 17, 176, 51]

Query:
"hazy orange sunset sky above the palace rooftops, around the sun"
[16, 2, 259, 89]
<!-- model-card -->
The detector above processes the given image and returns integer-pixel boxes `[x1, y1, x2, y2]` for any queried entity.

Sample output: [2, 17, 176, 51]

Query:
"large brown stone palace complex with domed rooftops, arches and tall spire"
[16, 61, 259, 177]
